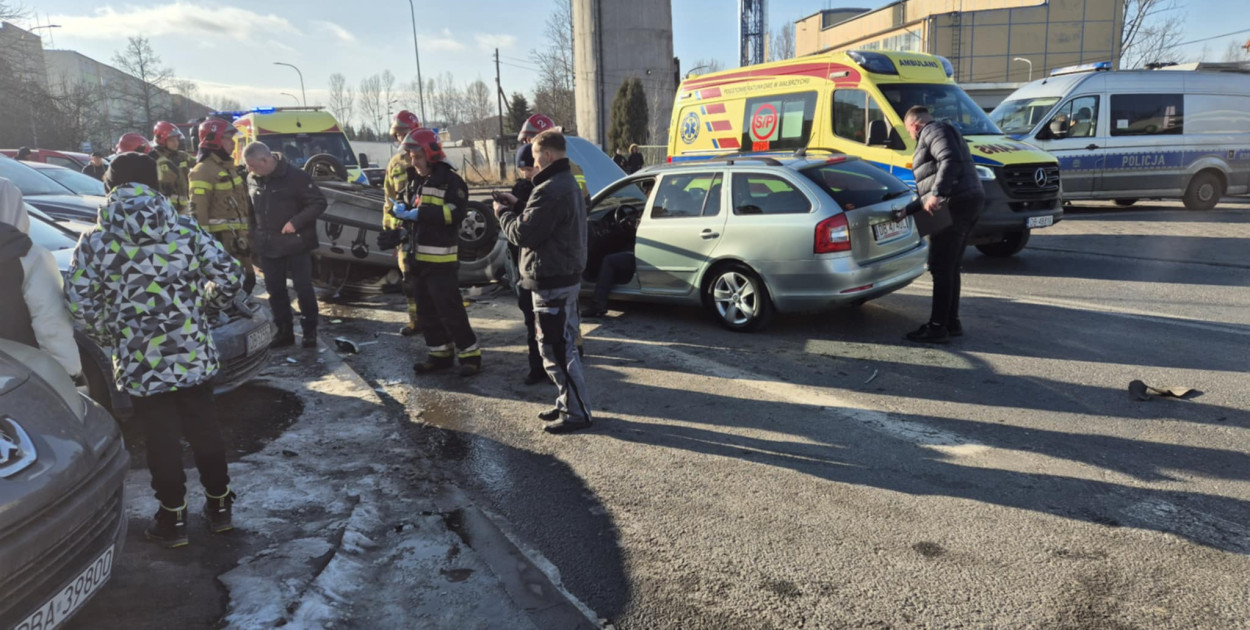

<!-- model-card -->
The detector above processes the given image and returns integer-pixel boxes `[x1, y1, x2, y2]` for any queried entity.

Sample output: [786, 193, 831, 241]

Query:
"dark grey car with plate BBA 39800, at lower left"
[0, 340, 130, 630]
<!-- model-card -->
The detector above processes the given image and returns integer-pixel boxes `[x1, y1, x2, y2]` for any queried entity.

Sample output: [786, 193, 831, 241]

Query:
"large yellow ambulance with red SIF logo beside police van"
[669, 51, 1063, 256]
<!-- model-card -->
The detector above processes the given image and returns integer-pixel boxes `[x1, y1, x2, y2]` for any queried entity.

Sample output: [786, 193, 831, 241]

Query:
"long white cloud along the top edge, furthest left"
[53, 3, 301, 41]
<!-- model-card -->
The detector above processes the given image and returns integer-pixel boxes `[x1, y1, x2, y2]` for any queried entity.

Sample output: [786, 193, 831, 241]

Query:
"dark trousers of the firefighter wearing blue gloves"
[409, 263, 478, 354]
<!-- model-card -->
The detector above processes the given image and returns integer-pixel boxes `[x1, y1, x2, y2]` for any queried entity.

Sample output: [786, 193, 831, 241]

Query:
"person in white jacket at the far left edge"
[0, 178, 83, 380]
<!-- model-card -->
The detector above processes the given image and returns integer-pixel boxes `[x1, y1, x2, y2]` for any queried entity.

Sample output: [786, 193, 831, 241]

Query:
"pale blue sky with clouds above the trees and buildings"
[26, 0, 1250, 119]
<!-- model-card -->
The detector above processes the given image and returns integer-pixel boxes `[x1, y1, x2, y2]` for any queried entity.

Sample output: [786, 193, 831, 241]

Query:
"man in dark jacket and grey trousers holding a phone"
[495, 130, 591, 434]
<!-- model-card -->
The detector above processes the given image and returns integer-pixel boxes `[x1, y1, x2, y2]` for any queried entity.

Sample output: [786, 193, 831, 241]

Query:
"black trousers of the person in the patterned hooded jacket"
[133, 384, 230, 509]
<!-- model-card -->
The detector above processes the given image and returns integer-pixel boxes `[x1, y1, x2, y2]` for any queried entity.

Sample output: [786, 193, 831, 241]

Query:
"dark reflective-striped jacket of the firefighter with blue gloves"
[404, 161, 469, 265]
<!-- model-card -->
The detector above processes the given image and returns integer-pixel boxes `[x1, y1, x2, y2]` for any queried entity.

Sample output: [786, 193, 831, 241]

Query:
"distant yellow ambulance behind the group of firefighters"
[223, 106, 369, 186]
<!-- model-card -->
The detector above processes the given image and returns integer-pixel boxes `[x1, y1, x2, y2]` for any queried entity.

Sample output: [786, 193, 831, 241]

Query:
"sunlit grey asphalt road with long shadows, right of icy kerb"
[326, 200, 1250, 630]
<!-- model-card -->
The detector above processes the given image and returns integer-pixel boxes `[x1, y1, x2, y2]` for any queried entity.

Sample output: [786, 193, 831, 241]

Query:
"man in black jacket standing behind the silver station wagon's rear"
[904, 106, 985, 344]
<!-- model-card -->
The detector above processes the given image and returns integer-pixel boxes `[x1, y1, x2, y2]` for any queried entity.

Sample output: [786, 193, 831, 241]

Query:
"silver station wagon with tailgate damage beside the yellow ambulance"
[583, 151, 929, 331]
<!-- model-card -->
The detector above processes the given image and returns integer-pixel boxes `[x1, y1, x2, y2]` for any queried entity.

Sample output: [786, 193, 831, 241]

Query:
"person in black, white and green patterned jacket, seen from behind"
[65, 153, 243, 548]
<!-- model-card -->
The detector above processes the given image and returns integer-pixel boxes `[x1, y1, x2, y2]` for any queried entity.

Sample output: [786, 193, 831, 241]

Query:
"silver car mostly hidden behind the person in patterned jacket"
[26, 204, 273, 419]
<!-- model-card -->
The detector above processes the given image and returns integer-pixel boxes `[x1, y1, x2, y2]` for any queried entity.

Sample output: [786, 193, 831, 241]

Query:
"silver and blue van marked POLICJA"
[990, 63, 1250, 210]
